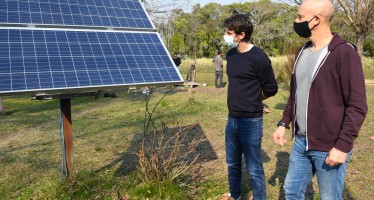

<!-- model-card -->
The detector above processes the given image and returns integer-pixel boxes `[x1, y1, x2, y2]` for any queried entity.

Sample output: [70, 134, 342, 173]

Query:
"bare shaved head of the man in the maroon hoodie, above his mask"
[299, 0, 334, 22]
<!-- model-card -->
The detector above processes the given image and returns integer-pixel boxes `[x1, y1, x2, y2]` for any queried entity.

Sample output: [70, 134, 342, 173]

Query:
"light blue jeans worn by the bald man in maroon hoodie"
[284, 135, 351, 200]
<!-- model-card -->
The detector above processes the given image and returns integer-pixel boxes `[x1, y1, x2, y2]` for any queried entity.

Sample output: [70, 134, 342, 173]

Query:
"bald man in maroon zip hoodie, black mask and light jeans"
[273, 0, 368, 200]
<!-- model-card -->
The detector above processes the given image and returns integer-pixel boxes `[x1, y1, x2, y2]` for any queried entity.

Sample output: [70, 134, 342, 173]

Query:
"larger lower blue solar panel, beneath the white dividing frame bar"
[0, 29, 181, 93]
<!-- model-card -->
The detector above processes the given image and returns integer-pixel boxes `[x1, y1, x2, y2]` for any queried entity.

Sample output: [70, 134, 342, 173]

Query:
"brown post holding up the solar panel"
[60, 98, 74, 177]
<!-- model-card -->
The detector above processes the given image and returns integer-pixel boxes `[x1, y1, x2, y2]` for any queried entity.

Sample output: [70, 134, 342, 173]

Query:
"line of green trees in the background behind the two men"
[148, 0, 374, 58]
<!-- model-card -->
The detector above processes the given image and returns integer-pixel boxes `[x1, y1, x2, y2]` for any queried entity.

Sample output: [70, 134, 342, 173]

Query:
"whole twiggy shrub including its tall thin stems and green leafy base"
[137, 89, 203, 199]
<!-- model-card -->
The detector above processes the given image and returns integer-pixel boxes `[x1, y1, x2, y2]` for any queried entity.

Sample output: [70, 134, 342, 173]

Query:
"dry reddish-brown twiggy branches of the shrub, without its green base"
[137, 119, 203, 183]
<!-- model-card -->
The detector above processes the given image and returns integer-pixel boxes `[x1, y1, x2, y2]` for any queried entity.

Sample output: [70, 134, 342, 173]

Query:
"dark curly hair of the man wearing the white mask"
[224, 13, 253, 42]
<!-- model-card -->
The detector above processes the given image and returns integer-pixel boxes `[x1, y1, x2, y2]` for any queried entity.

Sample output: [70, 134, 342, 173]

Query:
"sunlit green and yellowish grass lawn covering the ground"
[0, 66, 374, 199]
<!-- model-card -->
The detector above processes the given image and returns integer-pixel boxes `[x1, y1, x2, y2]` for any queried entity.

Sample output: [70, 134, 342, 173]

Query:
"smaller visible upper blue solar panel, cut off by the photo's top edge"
[0, 0, 154, 29]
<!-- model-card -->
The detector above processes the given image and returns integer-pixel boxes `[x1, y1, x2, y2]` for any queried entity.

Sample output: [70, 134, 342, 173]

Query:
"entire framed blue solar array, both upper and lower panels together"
[0, 0, 183, 95]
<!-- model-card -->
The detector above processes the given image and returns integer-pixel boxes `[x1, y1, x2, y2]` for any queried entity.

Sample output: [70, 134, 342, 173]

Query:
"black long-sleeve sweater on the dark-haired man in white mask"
[226, 46, 278, 118]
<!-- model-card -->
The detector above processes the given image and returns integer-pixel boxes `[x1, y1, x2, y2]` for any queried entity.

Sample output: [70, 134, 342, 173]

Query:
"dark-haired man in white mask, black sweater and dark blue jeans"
[224, 14, 278, 200]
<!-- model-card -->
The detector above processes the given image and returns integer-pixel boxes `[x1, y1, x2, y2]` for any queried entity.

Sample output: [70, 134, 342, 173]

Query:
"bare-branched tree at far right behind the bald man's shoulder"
[337, 0, 374, 56]
